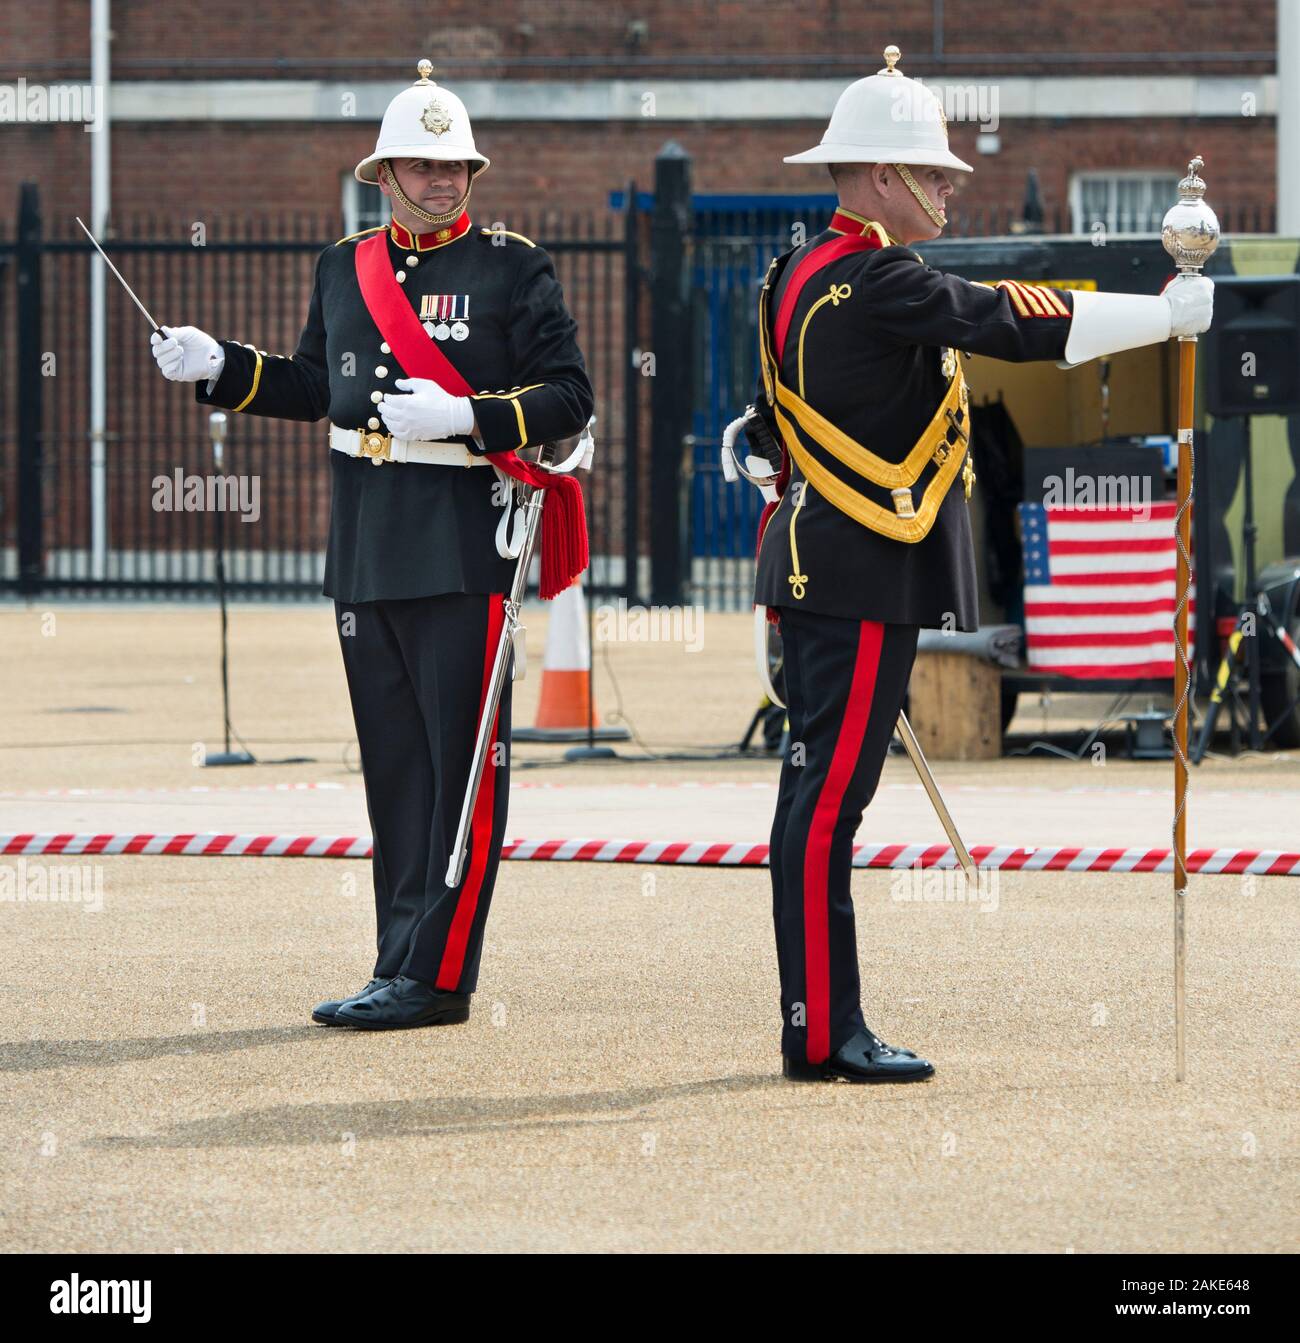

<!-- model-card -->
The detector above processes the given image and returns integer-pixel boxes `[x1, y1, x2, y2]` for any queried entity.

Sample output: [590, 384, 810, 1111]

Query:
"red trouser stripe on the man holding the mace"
[803, 620, 885, 1064]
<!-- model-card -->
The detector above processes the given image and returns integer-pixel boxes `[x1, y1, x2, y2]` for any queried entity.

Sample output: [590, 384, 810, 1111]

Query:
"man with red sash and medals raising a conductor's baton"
[153, 62, 592, 1029]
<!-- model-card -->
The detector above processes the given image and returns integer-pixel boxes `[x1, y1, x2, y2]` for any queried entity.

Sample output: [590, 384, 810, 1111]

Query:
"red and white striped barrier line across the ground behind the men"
[0, 833, 1300, 877]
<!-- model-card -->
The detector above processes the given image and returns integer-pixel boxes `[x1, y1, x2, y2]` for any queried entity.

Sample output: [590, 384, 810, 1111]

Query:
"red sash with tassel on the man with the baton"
[356, 232, 590, 602]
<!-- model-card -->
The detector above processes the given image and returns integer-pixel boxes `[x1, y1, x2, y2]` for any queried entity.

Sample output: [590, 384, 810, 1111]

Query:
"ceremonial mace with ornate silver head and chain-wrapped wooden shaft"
[1160, 157, 1219, 1081]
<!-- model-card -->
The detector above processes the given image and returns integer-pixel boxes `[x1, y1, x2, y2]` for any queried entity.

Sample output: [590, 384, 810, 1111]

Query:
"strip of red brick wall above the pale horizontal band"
[0, 0, 1276, 83]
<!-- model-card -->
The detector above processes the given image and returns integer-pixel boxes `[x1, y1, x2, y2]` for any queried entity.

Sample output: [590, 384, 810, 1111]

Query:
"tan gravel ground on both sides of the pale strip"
[0, 606, 1300, 1253]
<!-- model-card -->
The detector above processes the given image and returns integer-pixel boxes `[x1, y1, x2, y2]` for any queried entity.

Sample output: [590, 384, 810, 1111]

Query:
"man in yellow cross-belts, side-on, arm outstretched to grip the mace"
[751, 47, 1213, 1081]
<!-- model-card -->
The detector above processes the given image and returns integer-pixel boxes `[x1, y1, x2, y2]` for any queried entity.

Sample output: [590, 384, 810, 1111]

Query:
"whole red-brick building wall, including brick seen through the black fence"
[0, 0, 1276, 572]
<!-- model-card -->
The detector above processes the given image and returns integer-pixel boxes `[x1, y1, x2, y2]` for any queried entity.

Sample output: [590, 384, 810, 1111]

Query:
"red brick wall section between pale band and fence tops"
[0, 118, 1276, 236]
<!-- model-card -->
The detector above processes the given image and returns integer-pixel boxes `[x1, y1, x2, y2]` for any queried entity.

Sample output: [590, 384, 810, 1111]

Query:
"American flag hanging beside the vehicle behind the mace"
[1019, 504, 1195, 681]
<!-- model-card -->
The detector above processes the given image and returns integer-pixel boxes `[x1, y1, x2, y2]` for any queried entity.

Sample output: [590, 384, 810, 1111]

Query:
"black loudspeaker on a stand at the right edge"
[1201, 275, 1300, 419]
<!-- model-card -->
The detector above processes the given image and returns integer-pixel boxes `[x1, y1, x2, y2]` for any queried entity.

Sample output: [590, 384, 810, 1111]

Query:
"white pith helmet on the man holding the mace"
[786, 47, 975, 172]
